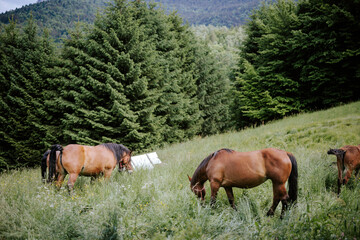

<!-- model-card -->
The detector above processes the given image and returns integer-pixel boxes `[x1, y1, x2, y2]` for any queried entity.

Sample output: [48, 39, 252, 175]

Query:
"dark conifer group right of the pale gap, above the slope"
[233, 0, 360, 127]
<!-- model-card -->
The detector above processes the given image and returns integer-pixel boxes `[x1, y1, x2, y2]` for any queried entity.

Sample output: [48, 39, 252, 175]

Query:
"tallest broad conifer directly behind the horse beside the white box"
[57, 1, 176, 149]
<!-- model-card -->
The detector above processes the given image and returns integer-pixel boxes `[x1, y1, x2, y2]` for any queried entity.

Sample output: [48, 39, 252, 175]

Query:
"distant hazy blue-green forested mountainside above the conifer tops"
[0, 0, 260, 42]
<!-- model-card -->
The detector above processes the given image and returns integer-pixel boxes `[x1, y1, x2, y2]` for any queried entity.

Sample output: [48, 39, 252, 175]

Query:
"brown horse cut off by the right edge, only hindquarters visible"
[328, 145, 360, 195]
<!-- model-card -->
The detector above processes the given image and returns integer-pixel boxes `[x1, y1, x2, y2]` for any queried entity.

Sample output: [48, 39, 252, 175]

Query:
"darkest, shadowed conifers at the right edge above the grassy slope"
[292, 0, 360, 109]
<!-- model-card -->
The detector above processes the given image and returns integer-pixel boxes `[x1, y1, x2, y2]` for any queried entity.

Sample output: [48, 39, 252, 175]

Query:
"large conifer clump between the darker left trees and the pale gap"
[58, 0, 207, 149]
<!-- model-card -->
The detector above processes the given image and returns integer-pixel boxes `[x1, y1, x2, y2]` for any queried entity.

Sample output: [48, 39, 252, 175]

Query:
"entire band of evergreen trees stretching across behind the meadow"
[0, 0, 360, 170]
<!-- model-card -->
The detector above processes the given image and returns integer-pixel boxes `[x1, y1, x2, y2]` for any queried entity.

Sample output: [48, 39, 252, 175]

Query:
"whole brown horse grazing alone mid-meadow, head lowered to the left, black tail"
[188, 148, 298, 217]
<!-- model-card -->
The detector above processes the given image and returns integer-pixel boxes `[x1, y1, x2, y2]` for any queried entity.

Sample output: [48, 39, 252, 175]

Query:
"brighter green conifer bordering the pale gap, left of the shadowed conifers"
[233, 0, 300, 127]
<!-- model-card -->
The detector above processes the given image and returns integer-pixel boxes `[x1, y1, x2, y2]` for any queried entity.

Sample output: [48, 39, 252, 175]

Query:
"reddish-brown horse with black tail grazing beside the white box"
[42, 143, 133, 192]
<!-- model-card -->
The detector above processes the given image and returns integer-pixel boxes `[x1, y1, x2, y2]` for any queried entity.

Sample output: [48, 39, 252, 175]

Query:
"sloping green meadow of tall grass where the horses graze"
[0, 102, 360, 239]
